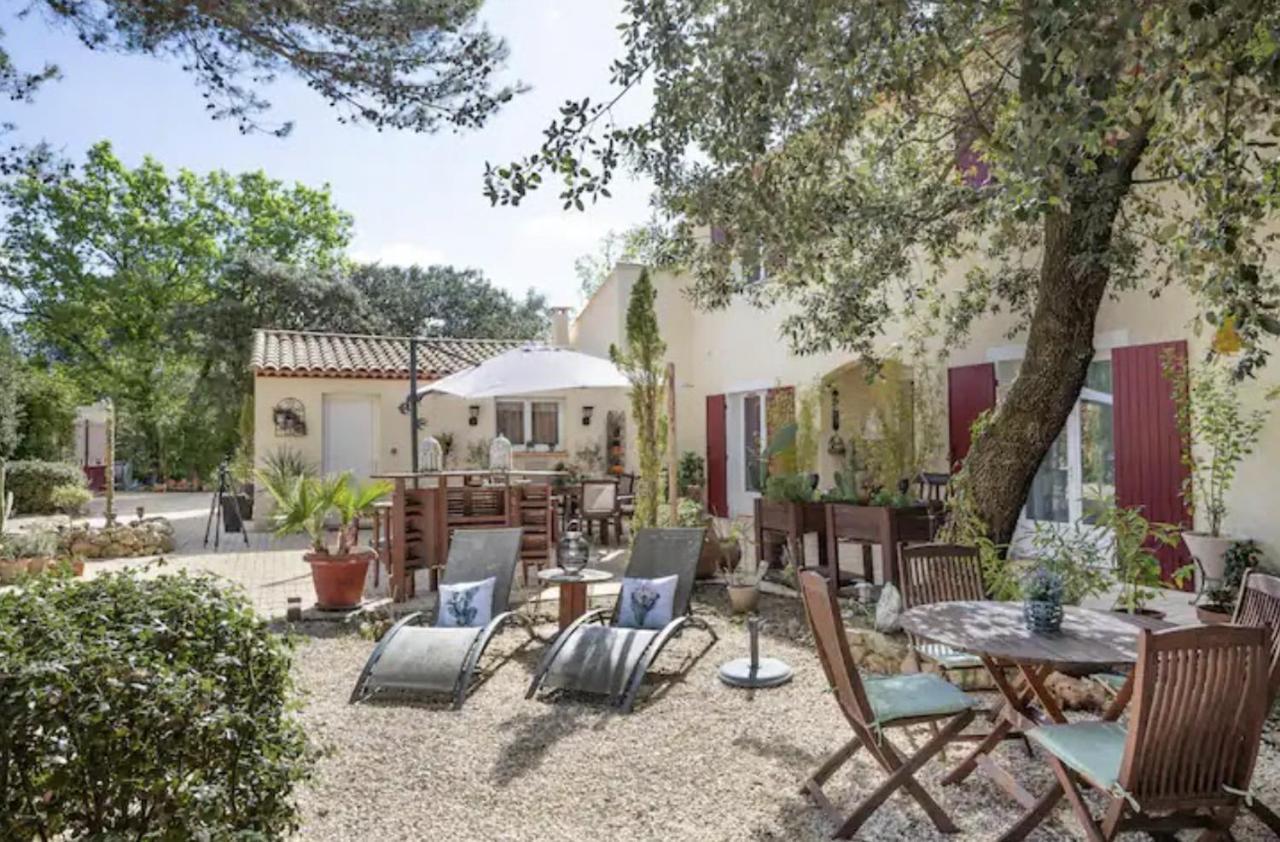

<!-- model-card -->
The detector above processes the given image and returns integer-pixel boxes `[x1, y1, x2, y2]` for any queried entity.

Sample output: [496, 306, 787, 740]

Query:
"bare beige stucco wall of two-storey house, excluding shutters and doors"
[573, 258, 1280, 566]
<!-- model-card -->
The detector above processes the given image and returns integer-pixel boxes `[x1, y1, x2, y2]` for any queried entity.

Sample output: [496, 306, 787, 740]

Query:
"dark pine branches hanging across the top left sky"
[0, 0, 520, 140]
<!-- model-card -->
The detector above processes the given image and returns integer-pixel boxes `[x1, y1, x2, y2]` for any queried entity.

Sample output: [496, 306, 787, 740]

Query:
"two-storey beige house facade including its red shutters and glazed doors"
[571, 264, 1280, 560]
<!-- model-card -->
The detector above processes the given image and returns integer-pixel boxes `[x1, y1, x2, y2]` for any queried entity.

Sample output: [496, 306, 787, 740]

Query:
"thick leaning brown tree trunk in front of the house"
[965, 144, 1146, 544]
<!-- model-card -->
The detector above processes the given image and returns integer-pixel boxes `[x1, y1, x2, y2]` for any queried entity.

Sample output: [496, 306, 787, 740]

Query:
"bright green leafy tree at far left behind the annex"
[0, 143, 351, 475]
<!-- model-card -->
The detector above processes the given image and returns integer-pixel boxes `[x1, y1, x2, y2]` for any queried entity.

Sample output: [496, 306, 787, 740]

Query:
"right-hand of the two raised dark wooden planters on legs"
[823, 503, 937, 587]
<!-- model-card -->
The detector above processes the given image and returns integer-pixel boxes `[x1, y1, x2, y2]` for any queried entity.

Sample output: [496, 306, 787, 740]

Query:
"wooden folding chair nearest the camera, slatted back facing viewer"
[1001, 626, 1271, 842]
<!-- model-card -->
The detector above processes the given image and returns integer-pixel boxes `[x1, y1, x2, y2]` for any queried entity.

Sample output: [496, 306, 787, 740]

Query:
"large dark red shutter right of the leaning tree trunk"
[1111, 340, 1192, 590]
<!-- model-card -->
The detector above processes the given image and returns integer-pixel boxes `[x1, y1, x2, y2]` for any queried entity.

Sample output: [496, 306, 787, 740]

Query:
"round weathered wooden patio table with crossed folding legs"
[902, 601, 1172, 810]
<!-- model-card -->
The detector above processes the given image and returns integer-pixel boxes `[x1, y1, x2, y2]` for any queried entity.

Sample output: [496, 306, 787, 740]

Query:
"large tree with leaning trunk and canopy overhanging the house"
[486, 0, 1280, 540]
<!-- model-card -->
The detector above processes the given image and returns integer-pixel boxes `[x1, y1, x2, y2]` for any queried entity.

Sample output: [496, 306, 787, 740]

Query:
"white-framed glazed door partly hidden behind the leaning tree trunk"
[996, 360, 1116, 523]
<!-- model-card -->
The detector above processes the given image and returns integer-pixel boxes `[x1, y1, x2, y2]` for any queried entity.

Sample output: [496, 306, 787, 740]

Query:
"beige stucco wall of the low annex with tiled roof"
[253, 375, 626, 511]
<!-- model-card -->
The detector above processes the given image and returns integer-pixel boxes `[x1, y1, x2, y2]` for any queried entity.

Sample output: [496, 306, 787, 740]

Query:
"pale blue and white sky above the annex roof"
[0, 0, 649, 306]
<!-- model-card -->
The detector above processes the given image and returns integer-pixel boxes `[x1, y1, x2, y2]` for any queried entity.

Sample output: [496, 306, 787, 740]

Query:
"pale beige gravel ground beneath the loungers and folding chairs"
[297, 589, 1280, 842]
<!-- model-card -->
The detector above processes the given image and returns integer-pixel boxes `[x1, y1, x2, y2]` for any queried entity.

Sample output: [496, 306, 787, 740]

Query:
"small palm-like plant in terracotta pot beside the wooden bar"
[262, 472, 392, 609]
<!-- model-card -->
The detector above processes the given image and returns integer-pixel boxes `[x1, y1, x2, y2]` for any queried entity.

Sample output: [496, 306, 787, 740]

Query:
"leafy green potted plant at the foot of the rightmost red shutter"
[1096, 505, 1194, 619]
